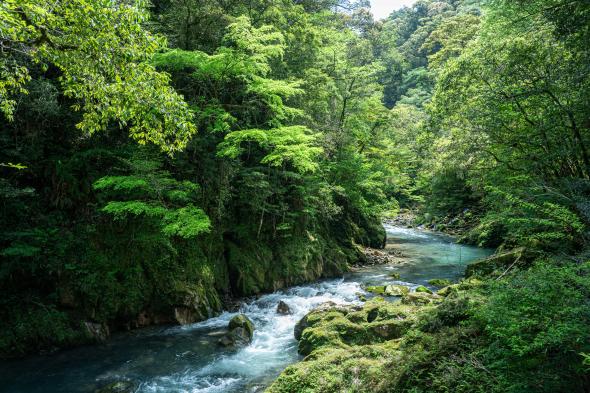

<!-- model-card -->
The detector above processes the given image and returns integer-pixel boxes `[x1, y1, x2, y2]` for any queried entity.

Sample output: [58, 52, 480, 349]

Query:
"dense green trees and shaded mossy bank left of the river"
[0, 0, 393, 356]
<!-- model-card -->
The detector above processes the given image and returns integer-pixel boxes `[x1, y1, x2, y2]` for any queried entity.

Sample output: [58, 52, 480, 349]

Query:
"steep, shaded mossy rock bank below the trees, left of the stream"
[0, 211, 385, 358]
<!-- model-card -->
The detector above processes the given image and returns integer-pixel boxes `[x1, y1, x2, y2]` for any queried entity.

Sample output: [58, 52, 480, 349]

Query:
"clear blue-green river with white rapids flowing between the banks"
[0, 225, 490, 393]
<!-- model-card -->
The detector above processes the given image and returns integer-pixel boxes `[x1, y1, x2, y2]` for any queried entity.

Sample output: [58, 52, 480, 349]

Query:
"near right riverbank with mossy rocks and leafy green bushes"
[267, 228, 590, 393]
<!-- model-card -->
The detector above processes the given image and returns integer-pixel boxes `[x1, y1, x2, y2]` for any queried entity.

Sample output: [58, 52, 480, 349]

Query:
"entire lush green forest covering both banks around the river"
[0, 0, 590, 393]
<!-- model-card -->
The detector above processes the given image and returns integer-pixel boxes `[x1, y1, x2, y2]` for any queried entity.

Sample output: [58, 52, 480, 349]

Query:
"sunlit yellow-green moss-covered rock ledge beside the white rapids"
[267, 279, 490, 393]
